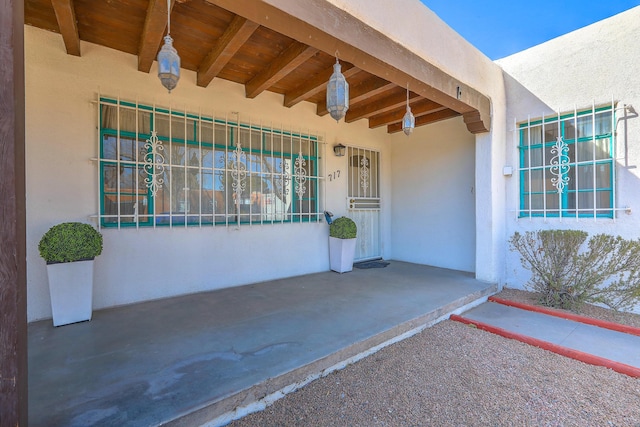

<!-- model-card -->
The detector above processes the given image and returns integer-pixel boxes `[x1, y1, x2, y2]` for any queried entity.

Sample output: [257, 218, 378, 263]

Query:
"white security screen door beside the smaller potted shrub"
[347, 147, 382, 261]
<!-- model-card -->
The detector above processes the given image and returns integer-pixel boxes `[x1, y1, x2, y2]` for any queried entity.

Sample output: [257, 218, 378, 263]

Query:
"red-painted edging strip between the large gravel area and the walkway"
[450, 314, 640, 378]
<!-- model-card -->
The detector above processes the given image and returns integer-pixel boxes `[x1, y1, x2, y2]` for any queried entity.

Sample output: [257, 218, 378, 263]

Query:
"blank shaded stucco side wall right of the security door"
[391, 118, 476, 271]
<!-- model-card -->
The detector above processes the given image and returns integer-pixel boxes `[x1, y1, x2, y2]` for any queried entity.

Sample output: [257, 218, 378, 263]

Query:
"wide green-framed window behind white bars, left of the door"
[99, 98, 321, 227]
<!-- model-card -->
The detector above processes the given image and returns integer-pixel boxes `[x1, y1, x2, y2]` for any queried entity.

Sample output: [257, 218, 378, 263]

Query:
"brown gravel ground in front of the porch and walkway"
[231, 289, 640, 427]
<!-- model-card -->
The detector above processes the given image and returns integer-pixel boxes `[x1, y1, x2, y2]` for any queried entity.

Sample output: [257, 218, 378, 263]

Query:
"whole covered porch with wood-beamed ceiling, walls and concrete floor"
[0, 0, 503, 425]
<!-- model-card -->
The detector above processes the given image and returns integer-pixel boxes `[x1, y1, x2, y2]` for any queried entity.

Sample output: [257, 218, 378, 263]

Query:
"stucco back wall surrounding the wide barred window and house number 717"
[25, 26, 392, 321]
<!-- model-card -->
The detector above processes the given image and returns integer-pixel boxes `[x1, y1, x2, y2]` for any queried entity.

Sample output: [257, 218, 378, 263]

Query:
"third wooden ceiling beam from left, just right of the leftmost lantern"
[197, 15, 260, 87]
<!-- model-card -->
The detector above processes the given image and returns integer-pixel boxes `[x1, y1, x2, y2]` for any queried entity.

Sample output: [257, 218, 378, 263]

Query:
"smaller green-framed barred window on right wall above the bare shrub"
[519, 104, 615, 218]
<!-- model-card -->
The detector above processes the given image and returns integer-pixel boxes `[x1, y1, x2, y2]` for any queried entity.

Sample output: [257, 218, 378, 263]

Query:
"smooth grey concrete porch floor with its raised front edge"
[28, 261, 497, 427]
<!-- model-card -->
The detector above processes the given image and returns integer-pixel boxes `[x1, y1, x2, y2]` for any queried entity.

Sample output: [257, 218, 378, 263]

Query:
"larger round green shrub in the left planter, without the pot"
[38, 222, 102, 264]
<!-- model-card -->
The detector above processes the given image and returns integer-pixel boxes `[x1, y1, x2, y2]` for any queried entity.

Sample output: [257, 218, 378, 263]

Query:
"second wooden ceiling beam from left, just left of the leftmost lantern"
[138, 0, 175, 73]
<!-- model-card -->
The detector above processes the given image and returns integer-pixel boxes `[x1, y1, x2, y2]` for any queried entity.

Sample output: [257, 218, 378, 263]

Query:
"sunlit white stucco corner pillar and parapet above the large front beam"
[324, 0, 506, 283]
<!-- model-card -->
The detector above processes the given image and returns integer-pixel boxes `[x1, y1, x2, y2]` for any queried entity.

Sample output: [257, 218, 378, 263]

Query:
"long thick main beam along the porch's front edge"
[206, 0, 491, 132]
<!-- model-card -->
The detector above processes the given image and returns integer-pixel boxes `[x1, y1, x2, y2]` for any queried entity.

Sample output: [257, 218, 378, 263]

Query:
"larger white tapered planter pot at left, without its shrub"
[47, 260, 93, 326]
